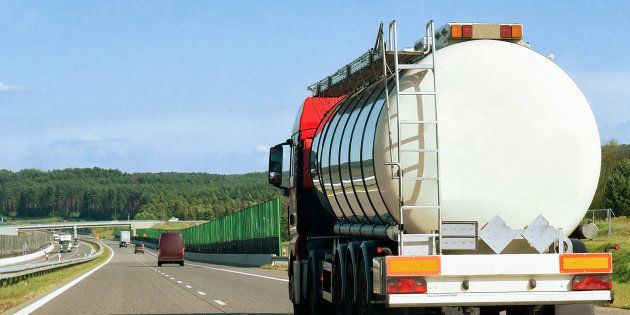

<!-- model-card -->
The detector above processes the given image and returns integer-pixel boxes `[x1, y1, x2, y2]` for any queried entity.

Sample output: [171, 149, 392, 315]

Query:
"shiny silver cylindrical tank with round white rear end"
[310, 40, 600, 235]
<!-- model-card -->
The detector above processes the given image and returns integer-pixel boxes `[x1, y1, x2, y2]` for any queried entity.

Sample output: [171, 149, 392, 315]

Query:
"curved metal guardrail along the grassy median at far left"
[0, 240, 105, 287]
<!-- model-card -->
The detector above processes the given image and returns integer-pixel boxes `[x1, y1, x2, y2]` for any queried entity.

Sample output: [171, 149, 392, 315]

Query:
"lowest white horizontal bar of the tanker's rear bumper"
[387, 291, 612, 307]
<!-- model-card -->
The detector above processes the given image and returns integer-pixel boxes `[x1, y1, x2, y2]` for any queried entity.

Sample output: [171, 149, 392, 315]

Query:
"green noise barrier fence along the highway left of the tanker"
[134, 198, 282, 255]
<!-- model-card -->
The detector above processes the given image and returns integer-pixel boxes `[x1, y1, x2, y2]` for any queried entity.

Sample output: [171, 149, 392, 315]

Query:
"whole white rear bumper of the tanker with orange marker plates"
[372, 253, 613, 307]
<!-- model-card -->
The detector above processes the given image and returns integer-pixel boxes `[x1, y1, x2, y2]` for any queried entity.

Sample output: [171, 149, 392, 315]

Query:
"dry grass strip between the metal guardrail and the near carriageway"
[0, 245, 112, 313]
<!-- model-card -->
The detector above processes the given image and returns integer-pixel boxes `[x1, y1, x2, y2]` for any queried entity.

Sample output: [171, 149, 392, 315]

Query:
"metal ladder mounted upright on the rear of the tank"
[380, 20, 442, 255]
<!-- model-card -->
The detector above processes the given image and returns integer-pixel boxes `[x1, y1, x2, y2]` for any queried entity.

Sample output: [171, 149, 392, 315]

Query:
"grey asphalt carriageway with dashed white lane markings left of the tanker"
[29, 241, 292, 314]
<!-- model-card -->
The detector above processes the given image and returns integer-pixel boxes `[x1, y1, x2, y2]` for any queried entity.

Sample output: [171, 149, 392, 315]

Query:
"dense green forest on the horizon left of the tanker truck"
[0, 168, 281, 220]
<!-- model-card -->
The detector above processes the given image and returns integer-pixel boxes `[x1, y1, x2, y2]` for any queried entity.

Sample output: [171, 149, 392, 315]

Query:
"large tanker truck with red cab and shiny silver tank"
[269, 21, 613, 315]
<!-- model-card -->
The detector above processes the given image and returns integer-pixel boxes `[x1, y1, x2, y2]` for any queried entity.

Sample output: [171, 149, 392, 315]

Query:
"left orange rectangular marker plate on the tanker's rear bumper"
[386, 256, 441, 276]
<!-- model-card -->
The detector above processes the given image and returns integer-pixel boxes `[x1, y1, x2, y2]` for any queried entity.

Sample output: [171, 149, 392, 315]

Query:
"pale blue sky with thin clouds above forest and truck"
[0, 0, 630, 173]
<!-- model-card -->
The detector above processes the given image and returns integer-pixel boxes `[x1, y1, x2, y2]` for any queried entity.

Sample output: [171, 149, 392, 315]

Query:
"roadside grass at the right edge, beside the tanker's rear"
[584, 217, 630, 309]
